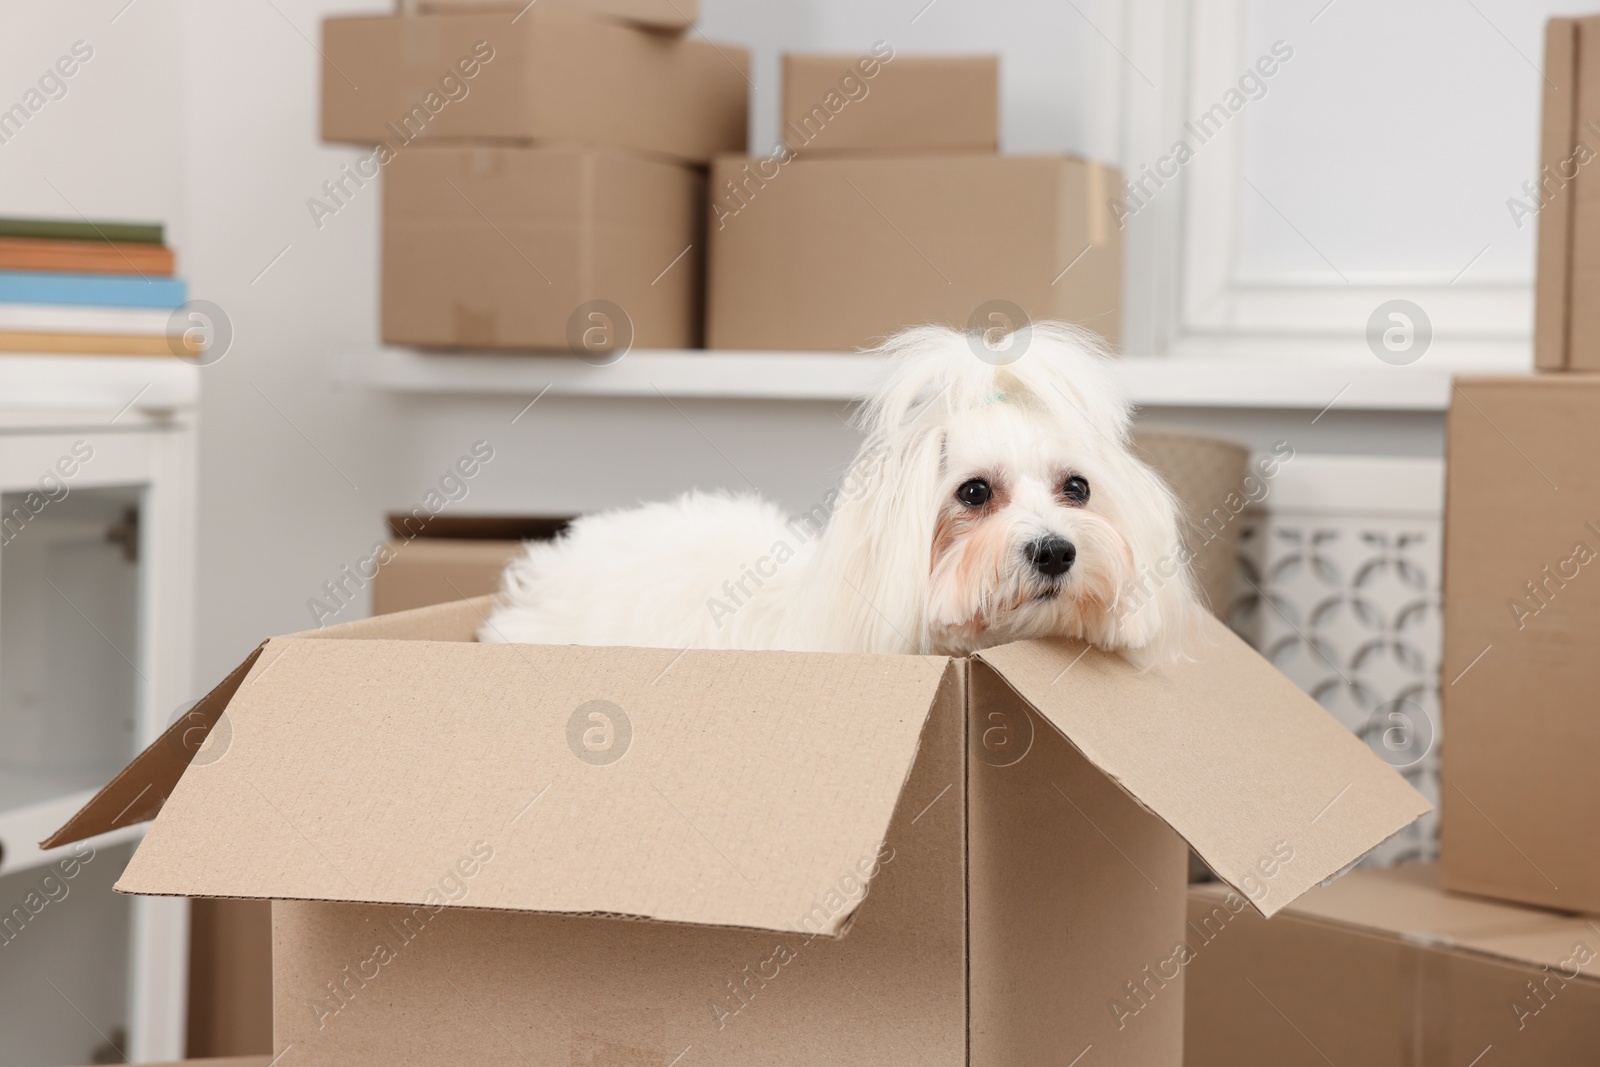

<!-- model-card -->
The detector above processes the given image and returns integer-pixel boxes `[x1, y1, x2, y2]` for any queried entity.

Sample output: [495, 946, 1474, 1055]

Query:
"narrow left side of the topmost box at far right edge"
[1533, 19, 1579, 371]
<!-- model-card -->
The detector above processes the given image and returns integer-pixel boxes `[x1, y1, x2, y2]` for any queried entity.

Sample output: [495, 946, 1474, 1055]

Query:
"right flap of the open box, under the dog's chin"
[978, 616, 1430, 917]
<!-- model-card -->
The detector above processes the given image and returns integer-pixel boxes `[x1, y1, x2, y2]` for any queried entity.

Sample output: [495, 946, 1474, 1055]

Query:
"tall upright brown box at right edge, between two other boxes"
[1440, 373, 1600, 912]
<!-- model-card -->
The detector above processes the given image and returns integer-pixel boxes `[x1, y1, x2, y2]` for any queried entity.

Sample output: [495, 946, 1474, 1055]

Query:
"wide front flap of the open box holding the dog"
[117, 639, 957, 936]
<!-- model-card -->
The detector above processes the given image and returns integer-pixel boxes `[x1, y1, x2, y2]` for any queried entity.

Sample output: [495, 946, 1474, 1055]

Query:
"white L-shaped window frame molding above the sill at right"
[1114, 0, 1533, 366]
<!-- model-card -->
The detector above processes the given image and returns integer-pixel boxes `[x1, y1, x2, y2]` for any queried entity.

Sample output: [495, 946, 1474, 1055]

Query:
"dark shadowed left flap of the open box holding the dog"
[38, 641, 266, 848]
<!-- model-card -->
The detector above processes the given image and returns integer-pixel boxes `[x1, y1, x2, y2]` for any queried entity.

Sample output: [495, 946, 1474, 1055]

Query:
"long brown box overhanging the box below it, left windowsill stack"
[322, 5, 750, 163]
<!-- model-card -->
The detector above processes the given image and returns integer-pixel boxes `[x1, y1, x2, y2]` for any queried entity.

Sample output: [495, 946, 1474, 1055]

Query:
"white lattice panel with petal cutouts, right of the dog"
[1229, 456, 1443, 865]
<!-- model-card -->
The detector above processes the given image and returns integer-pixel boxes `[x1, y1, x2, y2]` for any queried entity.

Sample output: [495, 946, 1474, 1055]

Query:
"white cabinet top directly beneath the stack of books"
[0, 354, 202, 426]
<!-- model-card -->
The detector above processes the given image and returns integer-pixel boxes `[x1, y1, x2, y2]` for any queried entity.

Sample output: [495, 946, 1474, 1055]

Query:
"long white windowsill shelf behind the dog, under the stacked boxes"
[339, 347, 1528, 411]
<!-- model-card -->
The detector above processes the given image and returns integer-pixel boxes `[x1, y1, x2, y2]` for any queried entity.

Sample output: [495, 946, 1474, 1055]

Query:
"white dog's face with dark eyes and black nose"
[928, 395, 1141, 654]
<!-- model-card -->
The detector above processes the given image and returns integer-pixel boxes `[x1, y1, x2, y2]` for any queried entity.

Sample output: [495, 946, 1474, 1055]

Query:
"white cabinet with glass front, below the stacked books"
[0, 357, 198, 1067]
